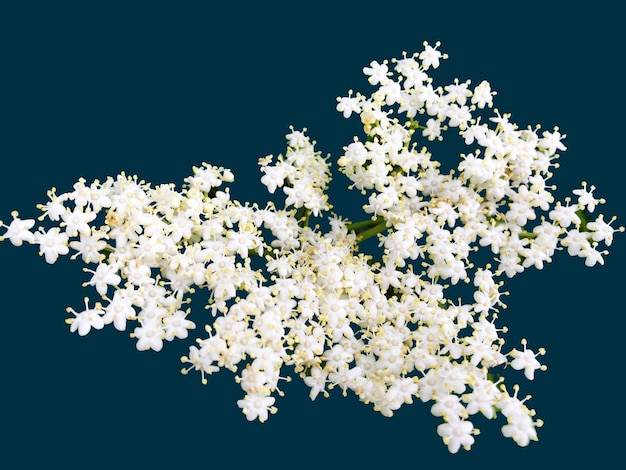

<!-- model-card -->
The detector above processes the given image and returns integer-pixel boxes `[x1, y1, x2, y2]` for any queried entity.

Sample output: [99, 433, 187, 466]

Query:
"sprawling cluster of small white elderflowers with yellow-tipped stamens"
[0, 43, 624, 453]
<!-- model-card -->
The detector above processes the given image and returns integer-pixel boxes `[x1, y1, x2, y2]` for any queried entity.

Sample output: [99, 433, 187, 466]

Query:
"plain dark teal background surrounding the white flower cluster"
[0, 1, 626, 469]
